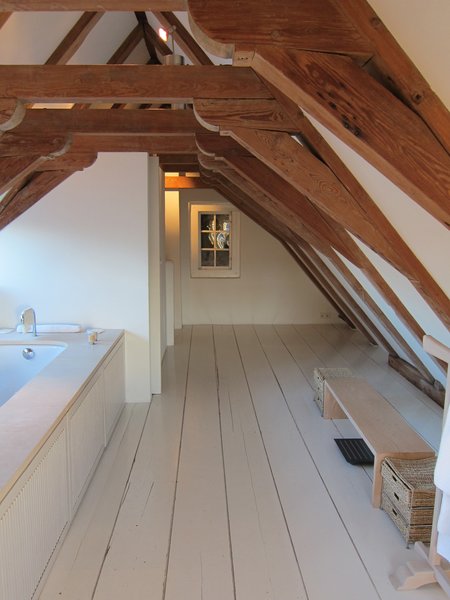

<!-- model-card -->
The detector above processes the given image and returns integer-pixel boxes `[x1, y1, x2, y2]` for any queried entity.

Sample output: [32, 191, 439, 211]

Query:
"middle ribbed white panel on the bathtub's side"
[69, 373, 104, 512]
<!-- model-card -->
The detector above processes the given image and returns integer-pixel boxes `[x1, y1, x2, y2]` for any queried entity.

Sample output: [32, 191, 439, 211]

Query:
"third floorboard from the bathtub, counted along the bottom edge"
[165, 325, 235, 600]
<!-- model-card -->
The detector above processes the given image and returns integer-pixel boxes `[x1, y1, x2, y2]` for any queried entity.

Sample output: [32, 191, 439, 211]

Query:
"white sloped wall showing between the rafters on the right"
[298, 0, 450, 385]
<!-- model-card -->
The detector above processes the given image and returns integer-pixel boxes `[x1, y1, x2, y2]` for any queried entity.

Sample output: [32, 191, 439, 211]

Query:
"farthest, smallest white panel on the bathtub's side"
[103, 341, 125, 443]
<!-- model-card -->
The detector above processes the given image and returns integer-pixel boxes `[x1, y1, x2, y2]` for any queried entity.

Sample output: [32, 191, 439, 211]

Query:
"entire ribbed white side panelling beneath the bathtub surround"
[0, 335, 125, 600]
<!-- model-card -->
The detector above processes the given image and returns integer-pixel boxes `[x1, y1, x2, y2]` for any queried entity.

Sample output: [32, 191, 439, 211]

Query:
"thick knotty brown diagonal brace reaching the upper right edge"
[251, 46, 450, 227]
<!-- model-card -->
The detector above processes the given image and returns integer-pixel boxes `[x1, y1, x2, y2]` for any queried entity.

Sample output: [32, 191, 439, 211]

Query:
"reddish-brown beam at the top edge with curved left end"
[189, 0, 373, 57]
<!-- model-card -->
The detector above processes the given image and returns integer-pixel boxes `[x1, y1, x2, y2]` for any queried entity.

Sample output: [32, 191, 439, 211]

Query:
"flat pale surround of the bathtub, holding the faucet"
[0, 329, 123, 502]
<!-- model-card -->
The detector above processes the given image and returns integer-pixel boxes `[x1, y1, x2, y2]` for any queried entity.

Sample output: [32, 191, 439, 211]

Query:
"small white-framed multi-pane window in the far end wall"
[189, 203, 240, 277]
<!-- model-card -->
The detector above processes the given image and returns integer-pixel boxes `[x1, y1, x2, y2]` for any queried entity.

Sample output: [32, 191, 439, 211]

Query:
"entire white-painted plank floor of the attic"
[41, 325, 444, 600]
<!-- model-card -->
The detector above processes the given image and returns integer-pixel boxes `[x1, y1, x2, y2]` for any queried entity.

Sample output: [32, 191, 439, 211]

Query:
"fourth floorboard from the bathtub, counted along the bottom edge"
[214, 326, 306, 600]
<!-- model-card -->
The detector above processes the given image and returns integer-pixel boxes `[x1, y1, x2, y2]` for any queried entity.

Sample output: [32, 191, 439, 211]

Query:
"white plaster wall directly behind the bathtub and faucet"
[0, 154, 150, 402]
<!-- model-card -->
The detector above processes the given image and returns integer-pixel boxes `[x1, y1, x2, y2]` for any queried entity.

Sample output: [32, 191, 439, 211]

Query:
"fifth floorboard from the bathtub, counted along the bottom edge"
[235, 326, 379, 600]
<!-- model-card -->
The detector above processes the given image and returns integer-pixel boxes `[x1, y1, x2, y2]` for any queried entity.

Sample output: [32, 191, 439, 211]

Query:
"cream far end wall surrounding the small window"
[180, 190, 339, 324]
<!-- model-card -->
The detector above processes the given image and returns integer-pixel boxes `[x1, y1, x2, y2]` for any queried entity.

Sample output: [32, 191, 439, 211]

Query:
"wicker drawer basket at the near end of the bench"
[381, 457, 436, 544]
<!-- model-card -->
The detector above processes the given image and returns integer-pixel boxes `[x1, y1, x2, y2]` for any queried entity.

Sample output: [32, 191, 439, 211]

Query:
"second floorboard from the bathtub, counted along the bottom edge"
[94, 328, 191, 600]
